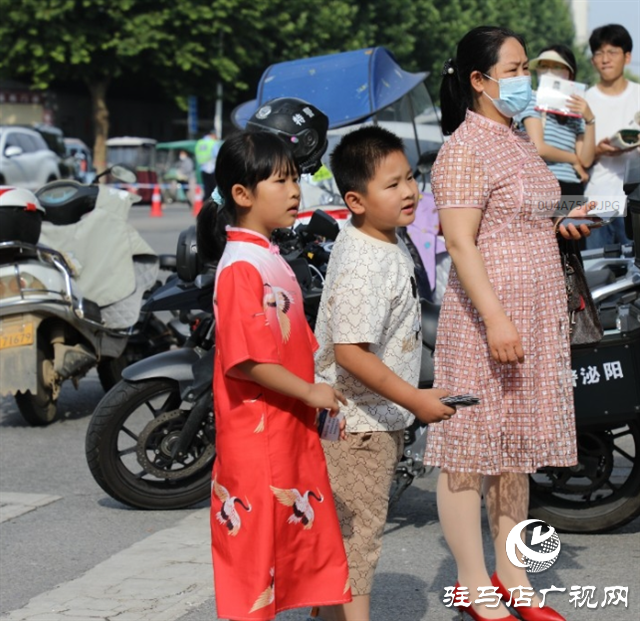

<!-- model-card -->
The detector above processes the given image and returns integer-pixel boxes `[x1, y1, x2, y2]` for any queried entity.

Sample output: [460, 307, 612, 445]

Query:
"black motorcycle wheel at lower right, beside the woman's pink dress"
[529, 421, 640, 533]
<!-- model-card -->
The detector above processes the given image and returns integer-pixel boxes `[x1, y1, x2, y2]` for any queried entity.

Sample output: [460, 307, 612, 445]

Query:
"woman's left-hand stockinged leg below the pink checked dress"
[437, 472, 508, 619]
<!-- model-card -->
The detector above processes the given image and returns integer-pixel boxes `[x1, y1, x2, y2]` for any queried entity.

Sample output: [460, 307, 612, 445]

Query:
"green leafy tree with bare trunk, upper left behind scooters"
[0, 0, 292, 167]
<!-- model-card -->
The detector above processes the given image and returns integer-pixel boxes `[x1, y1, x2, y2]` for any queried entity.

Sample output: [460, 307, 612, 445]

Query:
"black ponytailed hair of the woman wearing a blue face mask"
[440, 26, 527, 135]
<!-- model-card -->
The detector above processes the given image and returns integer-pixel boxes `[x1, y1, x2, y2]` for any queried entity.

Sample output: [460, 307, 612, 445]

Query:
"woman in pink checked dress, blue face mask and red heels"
[425, 27, 588, 621]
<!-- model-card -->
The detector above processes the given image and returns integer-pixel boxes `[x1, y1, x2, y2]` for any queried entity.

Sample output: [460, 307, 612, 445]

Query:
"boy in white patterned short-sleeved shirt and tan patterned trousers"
[315, 126, 455, 621]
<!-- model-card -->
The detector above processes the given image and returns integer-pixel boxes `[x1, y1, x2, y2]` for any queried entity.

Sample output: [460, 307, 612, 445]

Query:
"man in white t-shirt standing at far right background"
[585, 24, 640, 248]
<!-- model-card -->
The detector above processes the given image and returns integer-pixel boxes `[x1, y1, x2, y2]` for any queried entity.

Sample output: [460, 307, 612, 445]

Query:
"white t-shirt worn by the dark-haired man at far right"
[585, 82, 640, 196]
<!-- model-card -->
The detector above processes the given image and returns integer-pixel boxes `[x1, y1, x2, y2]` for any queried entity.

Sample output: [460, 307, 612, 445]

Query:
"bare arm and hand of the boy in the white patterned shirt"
[334, 343, 455, 423]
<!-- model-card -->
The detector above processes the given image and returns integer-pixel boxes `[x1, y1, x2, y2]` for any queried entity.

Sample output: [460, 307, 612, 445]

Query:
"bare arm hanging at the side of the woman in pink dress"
[439, 209, 524, 362]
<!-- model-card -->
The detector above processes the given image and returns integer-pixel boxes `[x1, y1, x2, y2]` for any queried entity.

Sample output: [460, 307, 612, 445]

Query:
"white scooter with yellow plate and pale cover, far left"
[0, 166, 177, 426]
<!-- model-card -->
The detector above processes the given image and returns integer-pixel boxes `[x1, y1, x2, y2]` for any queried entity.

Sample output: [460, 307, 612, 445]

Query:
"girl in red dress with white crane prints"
[198, 132, 351, 621]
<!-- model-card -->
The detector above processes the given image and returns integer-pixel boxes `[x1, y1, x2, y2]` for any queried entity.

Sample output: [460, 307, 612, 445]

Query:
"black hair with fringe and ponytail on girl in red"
[196, 132, 299, 263]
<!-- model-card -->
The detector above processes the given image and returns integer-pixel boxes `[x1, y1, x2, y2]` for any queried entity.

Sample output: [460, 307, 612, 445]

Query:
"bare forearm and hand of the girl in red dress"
[234, 360, 347, 412]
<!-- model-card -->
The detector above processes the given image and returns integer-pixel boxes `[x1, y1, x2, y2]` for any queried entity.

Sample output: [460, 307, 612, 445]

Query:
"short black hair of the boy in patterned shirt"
[331, 125, 404, 198]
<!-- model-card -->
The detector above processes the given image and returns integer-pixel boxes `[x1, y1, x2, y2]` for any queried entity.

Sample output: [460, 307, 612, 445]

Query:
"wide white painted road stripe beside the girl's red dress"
[0, 509, 214, 621]
